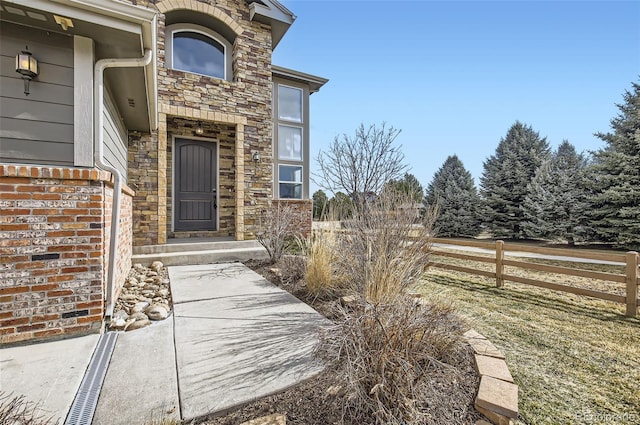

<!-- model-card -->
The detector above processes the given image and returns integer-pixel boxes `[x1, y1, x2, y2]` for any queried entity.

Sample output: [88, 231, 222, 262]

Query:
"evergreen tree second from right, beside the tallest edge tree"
[522, 140, 589, 245]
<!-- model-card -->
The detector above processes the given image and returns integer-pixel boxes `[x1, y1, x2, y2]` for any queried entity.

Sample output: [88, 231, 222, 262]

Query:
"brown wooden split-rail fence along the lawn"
[430, 238, 640, 317]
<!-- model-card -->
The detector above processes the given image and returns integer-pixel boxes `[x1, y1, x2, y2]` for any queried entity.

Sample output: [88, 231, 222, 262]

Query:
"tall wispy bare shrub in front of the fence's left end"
[337, 191, 435, 304]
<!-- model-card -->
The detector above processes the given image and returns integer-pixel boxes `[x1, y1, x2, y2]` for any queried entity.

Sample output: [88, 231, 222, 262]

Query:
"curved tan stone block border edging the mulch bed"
[464, 329, 518, 425]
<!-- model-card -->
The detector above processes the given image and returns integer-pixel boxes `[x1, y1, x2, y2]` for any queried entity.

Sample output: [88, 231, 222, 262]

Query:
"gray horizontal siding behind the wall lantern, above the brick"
[0, 22, 74, 165]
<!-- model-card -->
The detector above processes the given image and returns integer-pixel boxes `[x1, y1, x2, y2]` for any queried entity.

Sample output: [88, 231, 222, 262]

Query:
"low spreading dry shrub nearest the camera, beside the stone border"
[319, 296, 475, 424]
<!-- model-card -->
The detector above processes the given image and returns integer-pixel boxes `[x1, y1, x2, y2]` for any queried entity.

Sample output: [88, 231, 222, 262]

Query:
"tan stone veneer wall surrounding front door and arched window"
[129, 0, 273, 246]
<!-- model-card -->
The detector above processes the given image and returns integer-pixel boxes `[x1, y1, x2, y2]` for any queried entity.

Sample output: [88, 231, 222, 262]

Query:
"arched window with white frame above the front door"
[167, 24, 231, 80]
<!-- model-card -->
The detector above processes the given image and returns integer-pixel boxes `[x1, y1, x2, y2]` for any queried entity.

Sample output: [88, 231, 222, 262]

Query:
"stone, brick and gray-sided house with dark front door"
[0, 0, 327, 343]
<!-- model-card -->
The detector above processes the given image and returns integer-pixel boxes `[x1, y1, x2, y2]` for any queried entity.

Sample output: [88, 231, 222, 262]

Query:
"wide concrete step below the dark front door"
[131, 241, 268, 266]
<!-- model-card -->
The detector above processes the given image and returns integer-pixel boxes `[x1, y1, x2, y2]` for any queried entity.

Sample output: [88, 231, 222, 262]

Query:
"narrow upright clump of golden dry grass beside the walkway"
[304, 227, 344, 297]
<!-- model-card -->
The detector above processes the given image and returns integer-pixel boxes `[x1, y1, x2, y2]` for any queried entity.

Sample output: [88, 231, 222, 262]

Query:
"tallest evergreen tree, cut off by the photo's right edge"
[592, 79, 640, 249]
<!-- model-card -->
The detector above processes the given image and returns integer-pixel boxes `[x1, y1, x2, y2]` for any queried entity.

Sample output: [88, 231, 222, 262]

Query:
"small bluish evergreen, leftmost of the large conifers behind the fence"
[424, 155, 481, 237]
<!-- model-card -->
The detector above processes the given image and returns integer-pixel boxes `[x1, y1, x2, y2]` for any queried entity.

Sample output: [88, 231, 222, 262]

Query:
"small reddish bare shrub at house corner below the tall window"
[256, 202, 299, 264]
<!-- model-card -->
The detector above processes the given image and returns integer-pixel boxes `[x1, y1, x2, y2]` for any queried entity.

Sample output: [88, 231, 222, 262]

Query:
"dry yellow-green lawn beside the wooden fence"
[417, 258, 640, 425]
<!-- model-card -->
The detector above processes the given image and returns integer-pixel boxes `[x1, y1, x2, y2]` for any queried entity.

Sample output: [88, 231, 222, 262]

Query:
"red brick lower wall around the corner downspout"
[0, 165, 133, 344]
